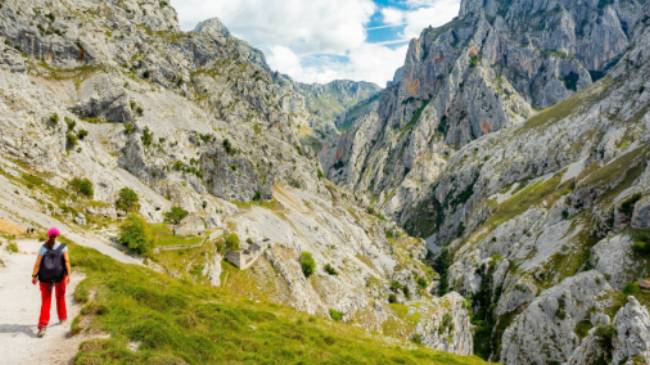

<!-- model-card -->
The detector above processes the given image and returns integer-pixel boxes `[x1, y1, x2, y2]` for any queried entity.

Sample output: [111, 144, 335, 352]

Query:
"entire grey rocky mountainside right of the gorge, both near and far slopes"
[321, 1, 650, 365]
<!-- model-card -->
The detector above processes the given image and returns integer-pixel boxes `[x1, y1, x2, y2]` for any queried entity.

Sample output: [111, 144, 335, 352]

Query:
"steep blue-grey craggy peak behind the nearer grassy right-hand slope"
[321, 0, 647, 222]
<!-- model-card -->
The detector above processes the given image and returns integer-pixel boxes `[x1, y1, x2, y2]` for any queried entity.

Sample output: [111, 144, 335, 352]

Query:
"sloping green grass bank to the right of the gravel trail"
[71, 245, 492, 365]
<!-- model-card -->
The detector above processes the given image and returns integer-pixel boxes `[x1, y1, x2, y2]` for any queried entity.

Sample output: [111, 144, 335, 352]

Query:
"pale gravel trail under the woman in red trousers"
[0, 240, 87, 365]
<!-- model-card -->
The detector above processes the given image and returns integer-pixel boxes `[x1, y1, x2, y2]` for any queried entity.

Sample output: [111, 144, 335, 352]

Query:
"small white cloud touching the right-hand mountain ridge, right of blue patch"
[404, 0, 460, 38]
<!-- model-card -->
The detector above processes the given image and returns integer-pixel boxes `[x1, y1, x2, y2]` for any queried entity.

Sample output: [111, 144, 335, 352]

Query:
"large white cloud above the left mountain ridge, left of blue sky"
[172, 0, 376, 55]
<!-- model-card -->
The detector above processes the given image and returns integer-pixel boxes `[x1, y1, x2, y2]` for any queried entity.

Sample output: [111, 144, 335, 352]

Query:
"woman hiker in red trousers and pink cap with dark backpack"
[32, 228, 71, 337]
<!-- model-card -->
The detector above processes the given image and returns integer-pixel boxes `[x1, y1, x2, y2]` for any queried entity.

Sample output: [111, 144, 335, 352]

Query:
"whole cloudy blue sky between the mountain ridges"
[171, 0, 460, 86]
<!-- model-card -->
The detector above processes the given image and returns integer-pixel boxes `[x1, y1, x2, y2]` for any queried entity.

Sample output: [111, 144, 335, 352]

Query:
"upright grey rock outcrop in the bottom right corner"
[612, 297, 650, 364]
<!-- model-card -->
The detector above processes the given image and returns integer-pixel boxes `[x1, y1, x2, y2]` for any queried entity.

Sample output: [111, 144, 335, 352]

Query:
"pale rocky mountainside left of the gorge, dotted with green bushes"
[0, 0, 473, 354]
